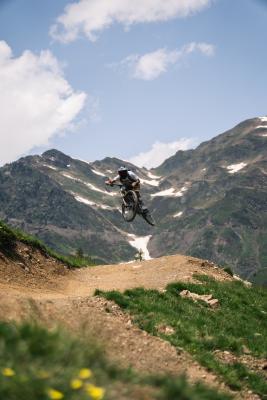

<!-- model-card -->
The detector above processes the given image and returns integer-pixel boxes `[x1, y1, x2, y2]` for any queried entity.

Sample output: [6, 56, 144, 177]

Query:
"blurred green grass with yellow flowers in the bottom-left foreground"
[0, 322, 231, 400]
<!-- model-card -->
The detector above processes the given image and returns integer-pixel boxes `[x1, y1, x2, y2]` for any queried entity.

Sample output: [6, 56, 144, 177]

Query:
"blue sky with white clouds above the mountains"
[0, 0, 267, 166]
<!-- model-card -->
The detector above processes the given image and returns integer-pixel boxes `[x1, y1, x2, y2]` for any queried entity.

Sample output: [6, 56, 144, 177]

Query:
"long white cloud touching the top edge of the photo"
[50, 0, 213, 43]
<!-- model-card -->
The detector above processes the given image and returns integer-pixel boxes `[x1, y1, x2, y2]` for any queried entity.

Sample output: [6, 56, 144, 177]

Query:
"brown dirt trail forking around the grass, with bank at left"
[0, 247, 250, 398]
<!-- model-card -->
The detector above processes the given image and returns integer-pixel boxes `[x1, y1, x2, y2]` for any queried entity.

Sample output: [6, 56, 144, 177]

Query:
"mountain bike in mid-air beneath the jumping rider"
[105, 183, 156, 226]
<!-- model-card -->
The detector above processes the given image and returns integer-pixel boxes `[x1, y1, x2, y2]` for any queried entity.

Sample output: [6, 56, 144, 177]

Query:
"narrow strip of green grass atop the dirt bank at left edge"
[0, 221, 95, 267]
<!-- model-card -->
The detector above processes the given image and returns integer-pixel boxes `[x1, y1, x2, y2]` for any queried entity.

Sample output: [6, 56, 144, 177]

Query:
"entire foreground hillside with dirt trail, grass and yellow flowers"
[0, 219, 267, 400]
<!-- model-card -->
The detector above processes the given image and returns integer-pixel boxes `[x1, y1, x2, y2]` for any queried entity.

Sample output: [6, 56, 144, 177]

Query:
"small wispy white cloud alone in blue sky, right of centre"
[114, 42, 215, 81]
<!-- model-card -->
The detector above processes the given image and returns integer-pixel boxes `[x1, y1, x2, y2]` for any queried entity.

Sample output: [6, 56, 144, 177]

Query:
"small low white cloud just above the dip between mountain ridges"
[129, 139, 193, 168]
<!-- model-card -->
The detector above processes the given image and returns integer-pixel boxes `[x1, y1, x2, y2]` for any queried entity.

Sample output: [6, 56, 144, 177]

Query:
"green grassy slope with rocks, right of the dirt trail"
[98, 276, 267, 396]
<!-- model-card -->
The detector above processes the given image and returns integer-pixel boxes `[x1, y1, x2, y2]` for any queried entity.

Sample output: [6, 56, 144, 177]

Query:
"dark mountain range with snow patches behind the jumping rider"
[0, 117, 267, 283]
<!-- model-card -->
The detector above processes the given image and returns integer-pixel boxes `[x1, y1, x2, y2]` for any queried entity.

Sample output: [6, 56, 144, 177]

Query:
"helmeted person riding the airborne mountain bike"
[106, 166, 148, 214]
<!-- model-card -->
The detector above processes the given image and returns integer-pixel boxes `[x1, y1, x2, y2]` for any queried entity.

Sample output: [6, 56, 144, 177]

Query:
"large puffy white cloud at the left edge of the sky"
[0, 41, 86, 164]
